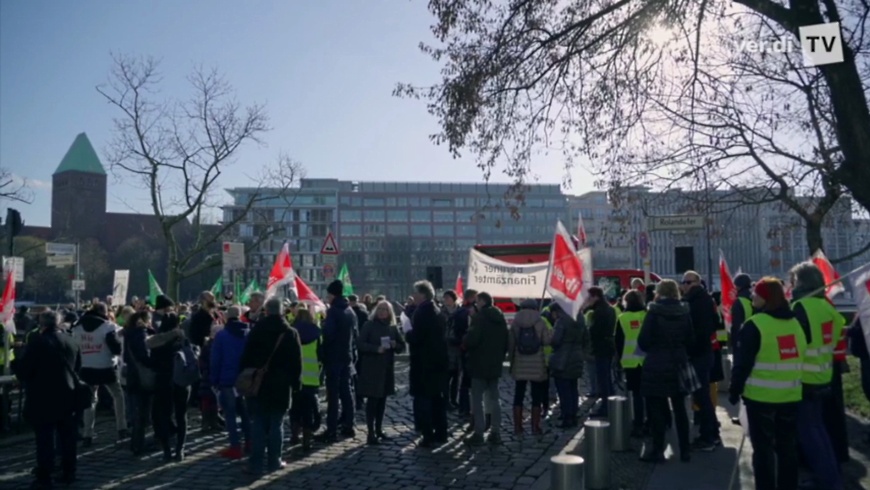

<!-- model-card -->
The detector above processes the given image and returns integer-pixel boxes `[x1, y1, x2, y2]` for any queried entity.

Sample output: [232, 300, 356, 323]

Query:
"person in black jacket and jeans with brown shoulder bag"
[239, 298, 302, 475]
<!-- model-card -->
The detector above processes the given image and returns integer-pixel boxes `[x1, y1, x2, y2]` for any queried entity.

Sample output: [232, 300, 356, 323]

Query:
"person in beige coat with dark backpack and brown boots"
[508, 299, 553, 435]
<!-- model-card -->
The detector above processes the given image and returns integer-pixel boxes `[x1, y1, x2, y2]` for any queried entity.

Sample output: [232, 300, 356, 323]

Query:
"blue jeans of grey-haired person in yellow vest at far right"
[800, 393, 843, 489]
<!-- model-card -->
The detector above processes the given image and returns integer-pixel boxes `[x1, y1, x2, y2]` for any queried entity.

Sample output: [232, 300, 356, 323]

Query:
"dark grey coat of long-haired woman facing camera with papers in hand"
[356, 320, 405, 398]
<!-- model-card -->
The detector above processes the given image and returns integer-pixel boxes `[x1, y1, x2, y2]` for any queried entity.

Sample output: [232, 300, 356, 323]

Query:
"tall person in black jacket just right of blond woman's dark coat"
[680, 271, 722, 452]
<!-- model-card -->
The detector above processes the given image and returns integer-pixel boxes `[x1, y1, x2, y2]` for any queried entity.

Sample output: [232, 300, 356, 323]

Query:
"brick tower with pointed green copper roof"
[51, 133, 108, 237]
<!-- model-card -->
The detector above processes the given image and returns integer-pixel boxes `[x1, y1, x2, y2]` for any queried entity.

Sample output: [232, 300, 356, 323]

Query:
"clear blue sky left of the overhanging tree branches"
[0, 0, 592, 226]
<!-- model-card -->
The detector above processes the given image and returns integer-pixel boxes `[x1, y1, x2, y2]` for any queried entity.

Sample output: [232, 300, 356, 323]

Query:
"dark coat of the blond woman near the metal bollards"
[637, 299, 696, 397]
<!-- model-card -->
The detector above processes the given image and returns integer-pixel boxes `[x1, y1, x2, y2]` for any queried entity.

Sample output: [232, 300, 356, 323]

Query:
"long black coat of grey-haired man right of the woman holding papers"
[405, 301, 448, 397]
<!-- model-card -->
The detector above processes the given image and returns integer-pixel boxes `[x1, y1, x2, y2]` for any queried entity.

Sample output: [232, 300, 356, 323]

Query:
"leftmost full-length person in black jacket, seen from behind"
[17, 311, 81, 488]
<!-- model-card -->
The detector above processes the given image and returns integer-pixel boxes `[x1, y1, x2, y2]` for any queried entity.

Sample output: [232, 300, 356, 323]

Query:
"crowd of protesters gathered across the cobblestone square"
[3, 258, 870, 489]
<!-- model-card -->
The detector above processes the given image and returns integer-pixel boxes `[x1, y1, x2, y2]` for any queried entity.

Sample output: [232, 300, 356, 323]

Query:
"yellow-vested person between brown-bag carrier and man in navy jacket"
[290, 307, 321, 451]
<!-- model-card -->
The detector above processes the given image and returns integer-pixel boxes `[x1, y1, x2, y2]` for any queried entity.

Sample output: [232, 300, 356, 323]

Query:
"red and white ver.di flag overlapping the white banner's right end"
[547, 221, 587, 318]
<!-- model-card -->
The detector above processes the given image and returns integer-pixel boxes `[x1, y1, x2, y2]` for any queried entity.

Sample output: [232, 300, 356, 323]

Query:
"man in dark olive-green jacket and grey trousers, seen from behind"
[463, 292, 508, 446]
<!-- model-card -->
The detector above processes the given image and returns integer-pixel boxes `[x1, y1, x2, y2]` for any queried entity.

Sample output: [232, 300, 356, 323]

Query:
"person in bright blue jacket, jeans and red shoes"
[209, 306, 251, 459]
